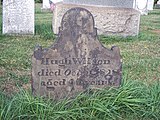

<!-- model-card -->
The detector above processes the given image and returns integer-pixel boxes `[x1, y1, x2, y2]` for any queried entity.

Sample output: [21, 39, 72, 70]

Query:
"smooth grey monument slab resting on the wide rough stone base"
[64, 0, 135, 8]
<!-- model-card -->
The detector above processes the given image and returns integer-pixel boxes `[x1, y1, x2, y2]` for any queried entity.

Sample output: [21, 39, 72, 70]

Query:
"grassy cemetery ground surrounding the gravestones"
[0, 4, 160, 120]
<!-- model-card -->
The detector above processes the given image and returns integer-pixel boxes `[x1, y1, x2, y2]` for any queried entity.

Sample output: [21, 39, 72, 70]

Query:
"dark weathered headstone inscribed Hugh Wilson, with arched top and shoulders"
[32, 8, 122, 99]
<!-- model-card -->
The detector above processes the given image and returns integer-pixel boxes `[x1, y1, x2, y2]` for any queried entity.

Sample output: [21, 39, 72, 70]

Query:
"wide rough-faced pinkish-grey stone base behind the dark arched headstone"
[52, 2, 140, 36]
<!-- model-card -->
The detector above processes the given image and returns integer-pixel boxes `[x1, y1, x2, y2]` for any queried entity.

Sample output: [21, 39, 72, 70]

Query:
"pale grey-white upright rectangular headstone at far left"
[3, 0, 34, 34]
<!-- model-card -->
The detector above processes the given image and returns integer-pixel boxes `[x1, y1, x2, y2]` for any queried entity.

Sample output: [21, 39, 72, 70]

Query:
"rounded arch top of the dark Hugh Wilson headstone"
[60, 7, 95, 34]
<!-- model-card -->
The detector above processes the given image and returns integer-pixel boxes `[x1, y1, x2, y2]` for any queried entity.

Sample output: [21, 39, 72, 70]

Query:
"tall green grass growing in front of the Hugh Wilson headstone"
[0, 80, 160, 120]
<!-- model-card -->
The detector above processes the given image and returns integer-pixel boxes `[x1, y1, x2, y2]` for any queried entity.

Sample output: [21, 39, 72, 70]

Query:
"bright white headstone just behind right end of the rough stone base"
[134, 0, 148, 15]
